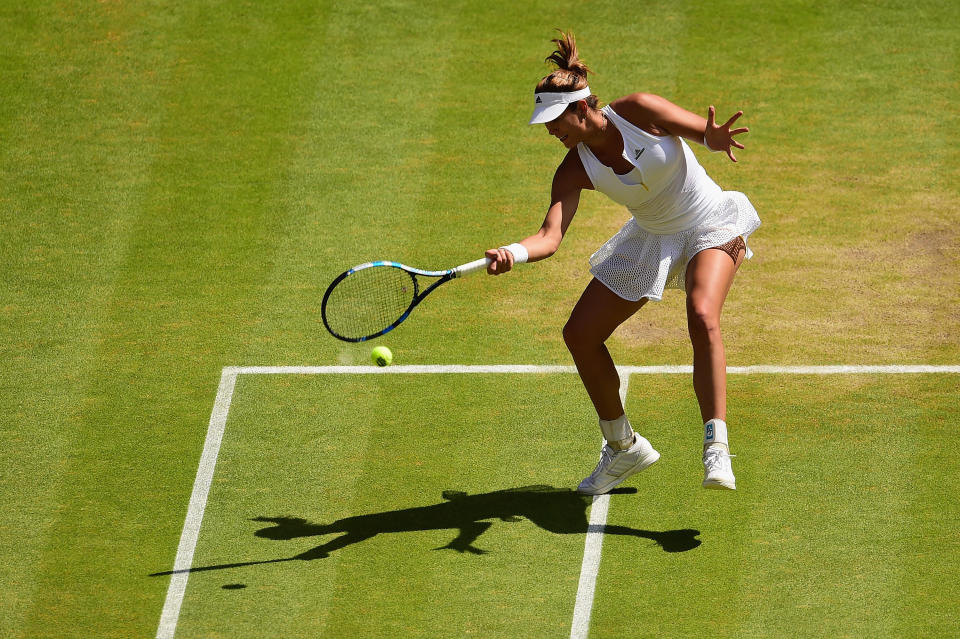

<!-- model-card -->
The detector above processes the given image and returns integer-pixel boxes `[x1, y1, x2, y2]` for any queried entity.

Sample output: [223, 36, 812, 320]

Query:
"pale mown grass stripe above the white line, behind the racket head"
[238, 4, 480, 370]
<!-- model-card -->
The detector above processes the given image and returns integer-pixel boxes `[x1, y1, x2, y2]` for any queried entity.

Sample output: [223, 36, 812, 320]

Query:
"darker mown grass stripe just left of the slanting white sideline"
[11, 6, 338, 636]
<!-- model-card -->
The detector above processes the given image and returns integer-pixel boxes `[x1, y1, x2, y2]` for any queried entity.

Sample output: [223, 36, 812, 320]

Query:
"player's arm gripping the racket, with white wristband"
[486, 148, 593, 275]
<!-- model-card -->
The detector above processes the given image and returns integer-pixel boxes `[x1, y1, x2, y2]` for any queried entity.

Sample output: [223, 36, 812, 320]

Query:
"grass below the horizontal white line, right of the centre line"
[594, 376, 960, 637]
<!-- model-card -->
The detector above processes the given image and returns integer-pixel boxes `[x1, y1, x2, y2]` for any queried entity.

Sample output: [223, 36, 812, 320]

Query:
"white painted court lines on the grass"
[157, 364, 960, 639]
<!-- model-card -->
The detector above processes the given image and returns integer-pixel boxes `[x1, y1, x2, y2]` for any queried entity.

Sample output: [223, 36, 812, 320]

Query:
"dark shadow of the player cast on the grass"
[151, 486, 701, 576]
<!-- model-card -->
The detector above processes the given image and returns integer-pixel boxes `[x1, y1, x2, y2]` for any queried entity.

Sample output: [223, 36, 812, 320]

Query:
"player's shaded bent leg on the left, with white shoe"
[563, 279, 660, 495]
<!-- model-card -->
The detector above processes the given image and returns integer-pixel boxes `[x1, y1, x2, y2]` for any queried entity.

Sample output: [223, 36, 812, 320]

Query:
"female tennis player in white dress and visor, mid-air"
[486, 33, 760, 495]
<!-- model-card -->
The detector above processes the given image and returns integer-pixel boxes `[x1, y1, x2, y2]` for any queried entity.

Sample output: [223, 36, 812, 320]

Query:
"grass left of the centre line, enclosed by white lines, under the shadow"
[172, 375, 595, 637]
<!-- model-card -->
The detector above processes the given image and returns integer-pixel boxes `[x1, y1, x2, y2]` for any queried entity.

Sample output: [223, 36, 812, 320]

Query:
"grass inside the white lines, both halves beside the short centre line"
[150, 374, 960, 637]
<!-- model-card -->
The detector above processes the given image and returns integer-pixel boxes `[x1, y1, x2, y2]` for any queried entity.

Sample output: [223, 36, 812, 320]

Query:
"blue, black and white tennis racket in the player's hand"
[320, 257, 492, 342]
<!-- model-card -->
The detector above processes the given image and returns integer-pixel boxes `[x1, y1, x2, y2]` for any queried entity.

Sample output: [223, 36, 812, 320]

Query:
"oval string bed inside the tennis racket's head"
[324, 266, 416, 339]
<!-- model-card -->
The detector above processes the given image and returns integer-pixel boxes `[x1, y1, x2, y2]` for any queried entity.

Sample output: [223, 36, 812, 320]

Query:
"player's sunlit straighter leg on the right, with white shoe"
[686, 237, 745, 489]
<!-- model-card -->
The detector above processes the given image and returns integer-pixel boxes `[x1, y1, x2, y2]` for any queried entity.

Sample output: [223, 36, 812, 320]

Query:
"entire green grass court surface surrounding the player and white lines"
[0, 0, 960, 637]
